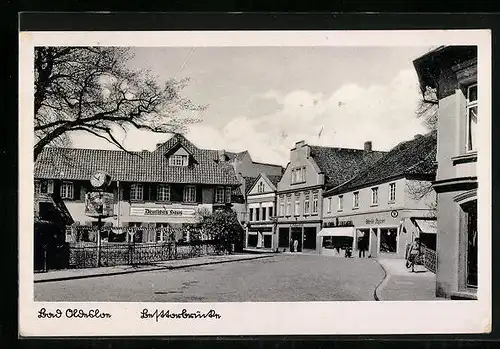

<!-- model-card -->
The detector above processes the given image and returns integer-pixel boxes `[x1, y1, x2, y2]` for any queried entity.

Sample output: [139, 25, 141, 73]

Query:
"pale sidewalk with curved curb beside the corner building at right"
[374, 259, 440, 301]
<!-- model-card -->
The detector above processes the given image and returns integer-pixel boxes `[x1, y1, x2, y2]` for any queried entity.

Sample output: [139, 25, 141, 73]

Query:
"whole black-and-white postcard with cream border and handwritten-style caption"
[19, 30, 491, 336]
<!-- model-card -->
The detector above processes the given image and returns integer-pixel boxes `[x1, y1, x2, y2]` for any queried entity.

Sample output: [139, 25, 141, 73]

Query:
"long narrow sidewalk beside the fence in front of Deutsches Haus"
[34, 253, 274, 283]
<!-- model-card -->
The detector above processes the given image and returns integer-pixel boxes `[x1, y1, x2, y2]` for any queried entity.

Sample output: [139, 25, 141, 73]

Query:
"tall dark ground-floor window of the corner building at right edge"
[462, 200, 477, 288]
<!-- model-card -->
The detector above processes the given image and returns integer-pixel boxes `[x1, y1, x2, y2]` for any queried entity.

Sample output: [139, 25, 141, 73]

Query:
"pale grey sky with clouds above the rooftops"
[71, 47, 431, 165]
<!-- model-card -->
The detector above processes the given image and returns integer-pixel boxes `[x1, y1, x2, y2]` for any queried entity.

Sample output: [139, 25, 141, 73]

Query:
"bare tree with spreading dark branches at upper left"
[34, 47, 205, 160]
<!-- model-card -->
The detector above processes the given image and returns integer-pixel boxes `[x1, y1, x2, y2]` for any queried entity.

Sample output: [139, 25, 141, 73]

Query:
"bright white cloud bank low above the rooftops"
[67, 69, 426, 165]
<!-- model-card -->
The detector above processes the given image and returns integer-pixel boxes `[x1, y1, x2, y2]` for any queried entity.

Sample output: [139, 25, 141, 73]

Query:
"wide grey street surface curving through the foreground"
[34, 254, 384, 302]
